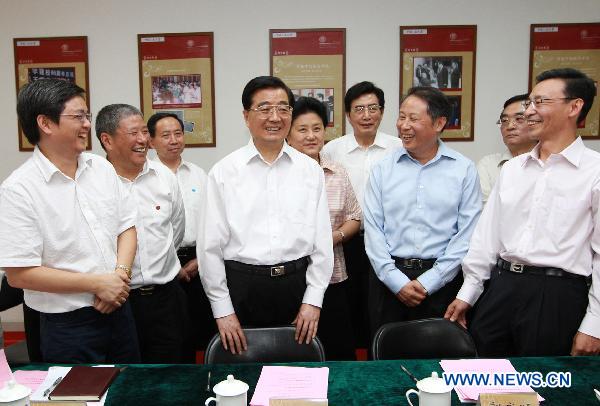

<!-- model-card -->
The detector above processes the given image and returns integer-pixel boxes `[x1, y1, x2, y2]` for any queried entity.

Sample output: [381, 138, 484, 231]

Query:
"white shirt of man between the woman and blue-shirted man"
[321, 131, 402, 211]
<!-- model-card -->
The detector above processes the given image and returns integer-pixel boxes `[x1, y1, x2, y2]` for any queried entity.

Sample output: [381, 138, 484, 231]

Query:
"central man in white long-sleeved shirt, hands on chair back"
[197, 76, 333, 353]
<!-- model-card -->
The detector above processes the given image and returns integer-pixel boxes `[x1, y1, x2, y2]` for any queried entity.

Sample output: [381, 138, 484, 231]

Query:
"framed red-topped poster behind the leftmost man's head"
[13, 37, 92, 151]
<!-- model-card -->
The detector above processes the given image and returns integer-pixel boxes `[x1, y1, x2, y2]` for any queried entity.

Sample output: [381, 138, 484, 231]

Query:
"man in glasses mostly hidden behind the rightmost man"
[477, 94, 537, 203]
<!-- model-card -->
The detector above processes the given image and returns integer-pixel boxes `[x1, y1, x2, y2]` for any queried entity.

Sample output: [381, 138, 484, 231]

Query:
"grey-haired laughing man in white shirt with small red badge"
[96, 104, 187, 363]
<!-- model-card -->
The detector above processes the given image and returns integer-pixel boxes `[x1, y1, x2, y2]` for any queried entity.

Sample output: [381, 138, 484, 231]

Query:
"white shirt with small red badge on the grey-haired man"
[121, 160, 185, 289]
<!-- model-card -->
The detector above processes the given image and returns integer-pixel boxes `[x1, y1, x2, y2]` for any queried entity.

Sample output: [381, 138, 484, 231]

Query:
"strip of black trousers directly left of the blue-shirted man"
[344, 232, 373, 348]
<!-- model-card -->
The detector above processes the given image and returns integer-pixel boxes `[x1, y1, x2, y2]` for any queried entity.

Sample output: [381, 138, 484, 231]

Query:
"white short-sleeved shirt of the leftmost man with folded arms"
[0, 147, 137, 313]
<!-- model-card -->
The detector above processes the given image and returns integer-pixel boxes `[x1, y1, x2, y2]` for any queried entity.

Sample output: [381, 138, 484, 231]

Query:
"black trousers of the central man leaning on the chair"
[225, 261, 308, 327]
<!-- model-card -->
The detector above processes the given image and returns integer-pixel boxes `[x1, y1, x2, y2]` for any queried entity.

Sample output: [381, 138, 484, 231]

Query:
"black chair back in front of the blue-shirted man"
[371, 319, 477, 360]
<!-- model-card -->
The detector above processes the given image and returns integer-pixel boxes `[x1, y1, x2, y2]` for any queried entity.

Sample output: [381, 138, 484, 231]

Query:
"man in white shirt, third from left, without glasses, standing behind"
[148, 112, 216, 363]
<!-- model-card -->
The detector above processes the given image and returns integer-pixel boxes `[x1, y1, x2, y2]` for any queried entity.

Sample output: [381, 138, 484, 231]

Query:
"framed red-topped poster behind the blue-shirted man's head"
[400, 25, 477, 141]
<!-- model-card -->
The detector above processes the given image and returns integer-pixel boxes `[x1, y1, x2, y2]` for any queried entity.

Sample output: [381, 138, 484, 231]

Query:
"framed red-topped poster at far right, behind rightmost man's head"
[529, 23, 600, 139]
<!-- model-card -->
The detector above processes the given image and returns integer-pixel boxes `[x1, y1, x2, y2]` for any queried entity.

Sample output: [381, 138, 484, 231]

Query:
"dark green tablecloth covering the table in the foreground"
[16, 357, 600, 406]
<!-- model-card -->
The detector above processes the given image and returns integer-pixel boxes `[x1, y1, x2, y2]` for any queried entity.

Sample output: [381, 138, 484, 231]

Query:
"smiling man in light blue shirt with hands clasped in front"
[364, 87, 481, 334]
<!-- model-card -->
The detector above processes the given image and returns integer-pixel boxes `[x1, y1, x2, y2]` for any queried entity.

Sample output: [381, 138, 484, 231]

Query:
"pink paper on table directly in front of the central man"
[250, 366, 329, 406]
